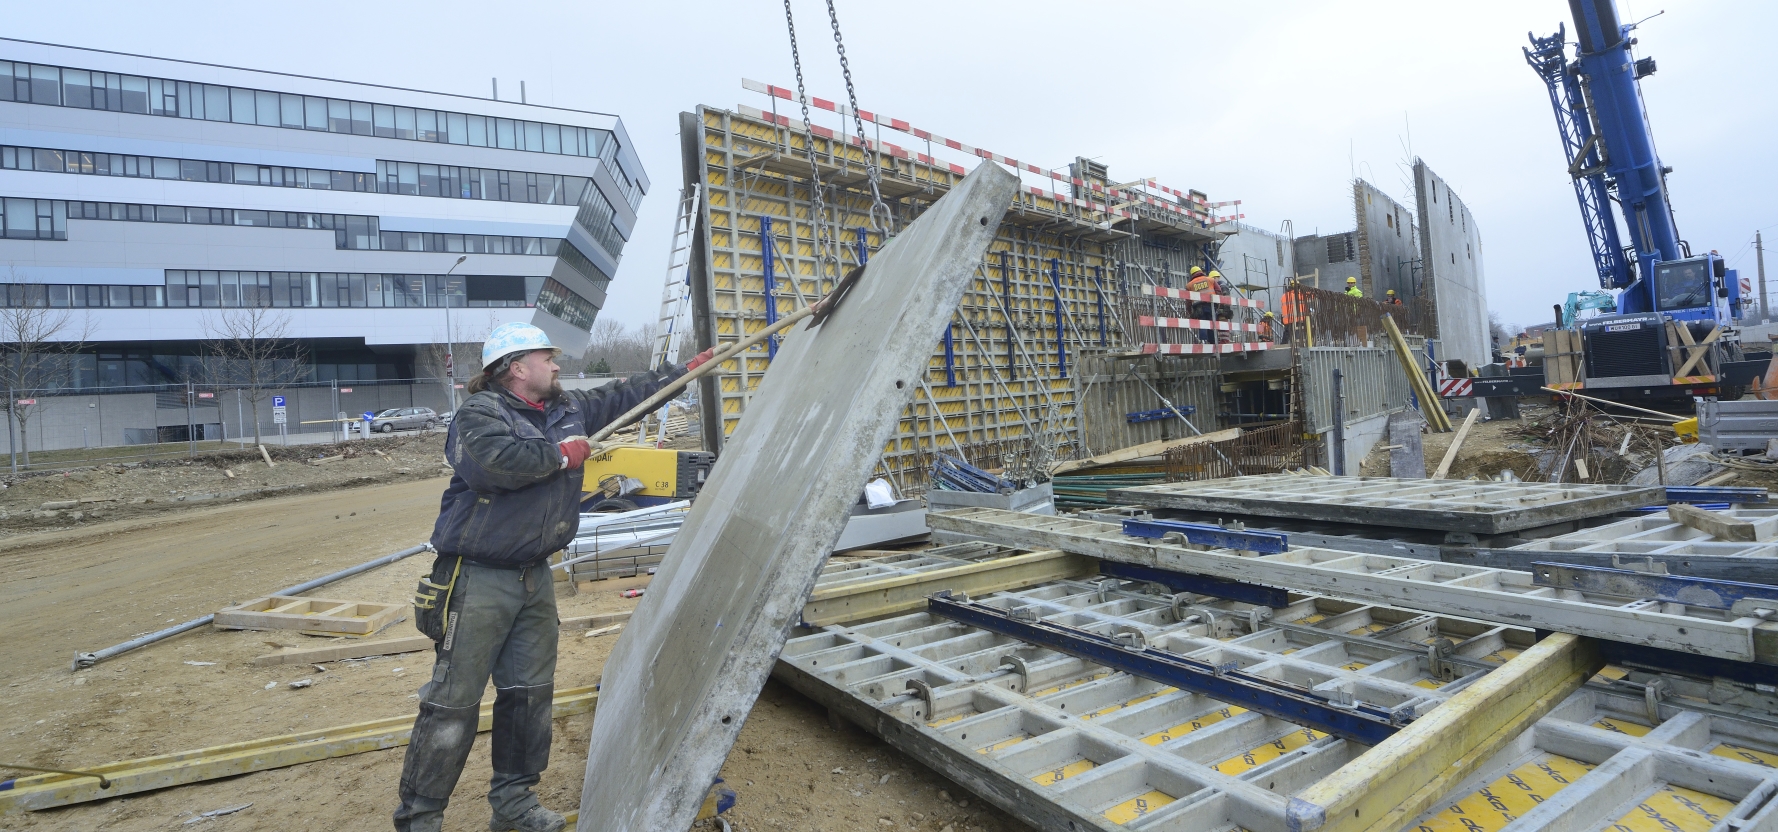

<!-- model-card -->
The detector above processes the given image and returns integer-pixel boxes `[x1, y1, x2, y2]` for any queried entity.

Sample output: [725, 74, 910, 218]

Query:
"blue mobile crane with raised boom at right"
[1526, 0, 1764, 398]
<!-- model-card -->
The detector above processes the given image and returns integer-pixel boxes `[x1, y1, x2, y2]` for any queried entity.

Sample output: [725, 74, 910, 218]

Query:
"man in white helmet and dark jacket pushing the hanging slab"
[395, 324, 711, 832]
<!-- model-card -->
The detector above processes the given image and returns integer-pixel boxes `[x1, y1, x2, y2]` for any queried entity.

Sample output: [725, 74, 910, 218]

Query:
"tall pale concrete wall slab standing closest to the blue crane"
[1414, 158, 1492, 366]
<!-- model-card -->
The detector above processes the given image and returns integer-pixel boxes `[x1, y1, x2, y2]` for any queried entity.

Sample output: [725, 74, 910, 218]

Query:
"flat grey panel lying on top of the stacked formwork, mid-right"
[1106, 475, 1666, 535]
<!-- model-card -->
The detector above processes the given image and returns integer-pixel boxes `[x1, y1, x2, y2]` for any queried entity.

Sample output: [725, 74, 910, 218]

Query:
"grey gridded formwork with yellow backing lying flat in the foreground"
[775, 560, 1778, 832]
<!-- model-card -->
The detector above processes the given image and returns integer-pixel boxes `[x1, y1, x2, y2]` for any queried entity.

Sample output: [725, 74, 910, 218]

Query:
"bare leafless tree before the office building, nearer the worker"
[201, 306, 308, 444]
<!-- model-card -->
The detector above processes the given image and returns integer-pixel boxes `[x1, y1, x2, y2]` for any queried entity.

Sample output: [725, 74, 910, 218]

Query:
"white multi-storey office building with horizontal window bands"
[0, 39, 649, 388]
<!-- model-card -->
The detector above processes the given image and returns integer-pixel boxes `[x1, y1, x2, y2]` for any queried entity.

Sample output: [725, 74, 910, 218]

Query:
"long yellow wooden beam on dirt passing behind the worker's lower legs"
[0, 686, 599, 814]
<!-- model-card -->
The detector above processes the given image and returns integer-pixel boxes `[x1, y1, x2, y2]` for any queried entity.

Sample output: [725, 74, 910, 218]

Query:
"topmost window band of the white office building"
[0, 60, 642, 208]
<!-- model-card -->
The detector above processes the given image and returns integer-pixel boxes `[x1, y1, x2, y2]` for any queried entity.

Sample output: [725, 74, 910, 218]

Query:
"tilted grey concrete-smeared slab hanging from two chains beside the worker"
[578, 164, 1017, 832]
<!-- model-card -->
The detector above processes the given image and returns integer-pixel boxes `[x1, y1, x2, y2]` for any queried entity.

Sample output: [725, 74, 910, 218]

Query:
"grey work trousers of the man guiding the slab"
[395, 555, 558, 830]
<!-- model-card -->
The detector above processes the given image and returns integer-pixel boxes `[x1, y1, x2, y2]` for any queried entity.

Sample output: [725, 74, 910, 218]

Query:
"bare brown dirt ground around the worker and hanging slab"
[0, 472, 1026, 832]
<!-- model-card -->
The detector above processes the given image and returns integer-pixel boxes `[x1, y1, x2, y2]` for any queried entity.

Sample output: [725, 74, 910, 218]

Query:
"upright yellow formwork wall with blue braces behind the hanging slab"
[681, 107, 1218, 492]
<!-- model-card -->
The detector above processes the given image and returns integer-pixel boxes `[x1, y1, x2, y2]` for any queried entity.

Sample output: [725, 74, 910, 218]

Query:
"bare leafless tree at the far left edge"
[0, 268, 91, 466]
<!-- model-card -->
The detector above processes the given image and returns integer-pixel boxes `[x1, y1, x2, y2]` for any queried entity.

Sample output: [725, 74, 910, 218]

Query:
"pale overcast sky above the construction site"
[7, 0, 1778, 325]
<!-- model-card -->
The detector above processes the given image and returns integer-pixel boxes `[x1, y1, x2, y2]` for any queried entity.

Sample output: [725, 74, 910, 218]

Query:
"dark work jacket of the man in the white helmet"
[432, 366, 685, 569]
